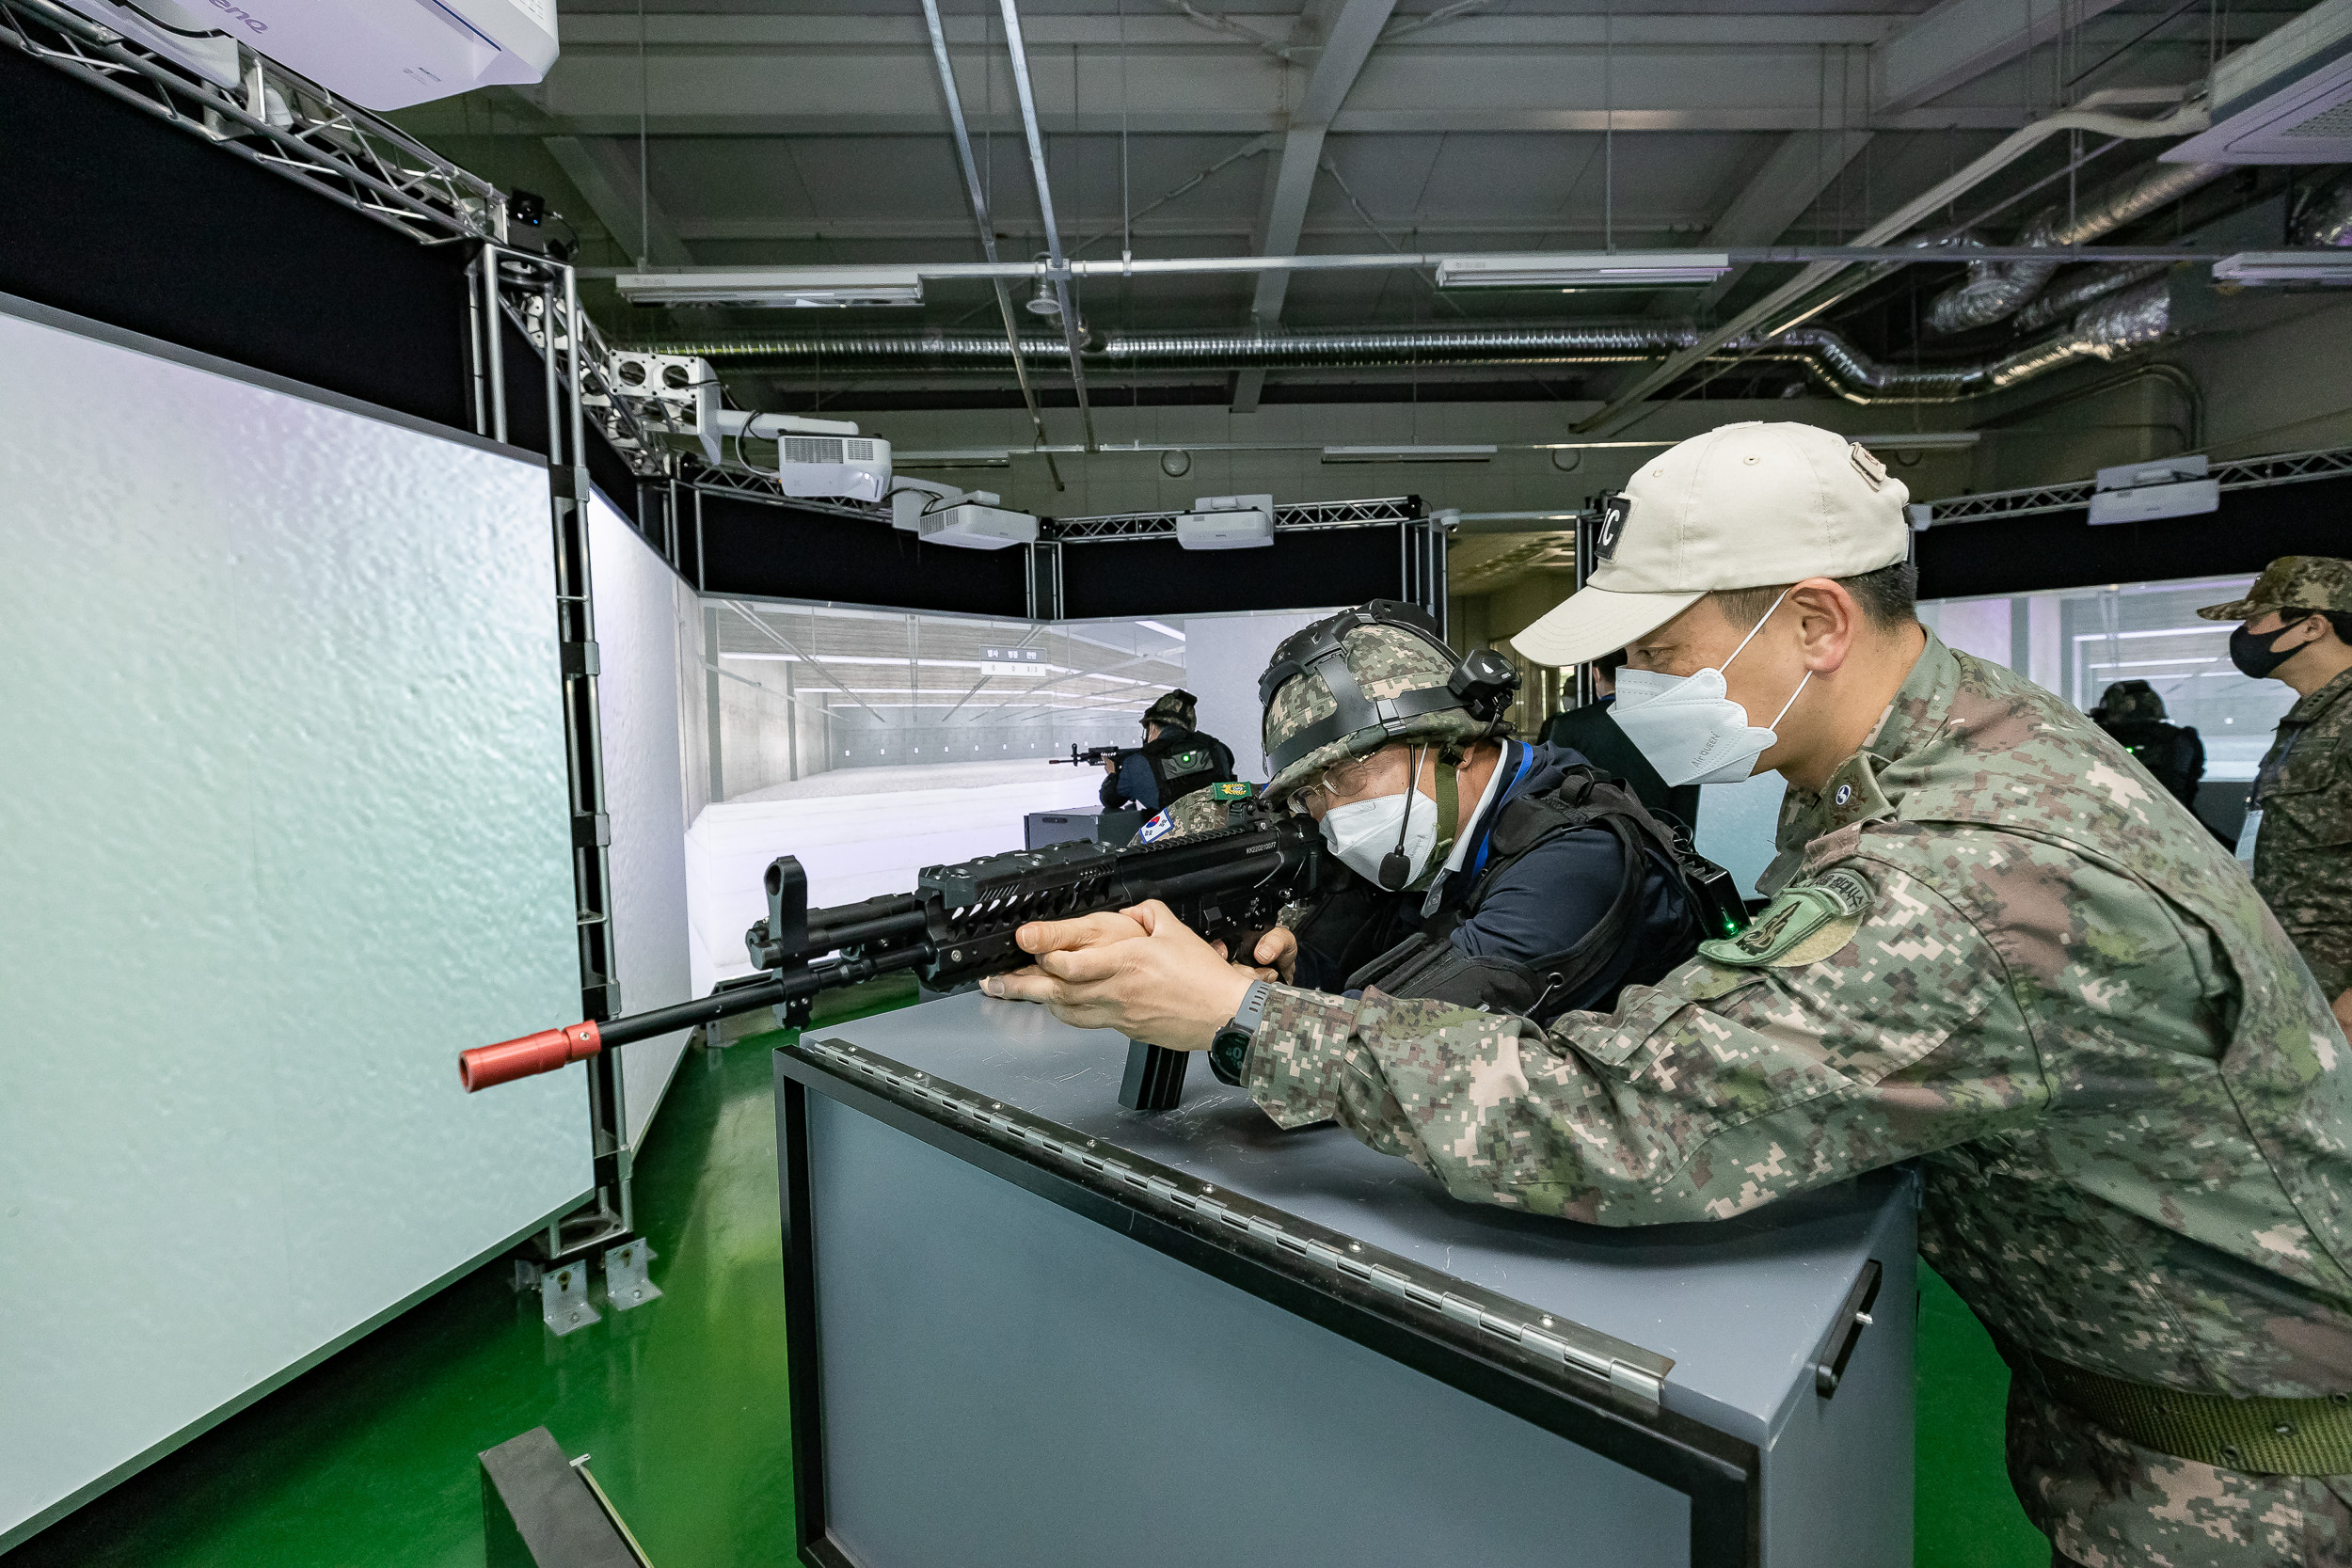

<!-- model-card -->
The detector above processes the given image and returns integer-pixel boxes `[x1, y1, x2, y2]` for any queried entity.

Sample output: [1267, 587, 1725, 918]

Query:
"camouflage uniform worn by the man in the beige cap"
[1247, 637, 2352, 1568]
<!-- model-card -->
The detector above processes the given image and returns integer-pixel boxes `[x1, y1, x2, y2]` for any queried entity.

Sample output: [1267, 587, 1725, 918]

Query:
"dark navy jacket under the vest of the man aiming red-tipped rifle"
[1296, 740, 1698, 1011]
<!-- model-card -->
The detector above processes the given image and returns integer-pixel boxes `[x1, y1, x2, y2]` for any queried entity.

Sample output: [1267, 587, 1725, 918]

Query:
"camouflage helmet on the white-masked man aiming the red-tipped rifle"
[1259, 599, 1519, 804]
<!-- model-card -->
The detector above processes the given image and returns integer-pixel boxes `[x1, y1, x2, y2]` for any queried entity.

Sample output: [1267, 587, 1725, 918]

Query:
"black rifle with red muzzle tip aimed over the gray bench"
[459, 806, 1334, 1110]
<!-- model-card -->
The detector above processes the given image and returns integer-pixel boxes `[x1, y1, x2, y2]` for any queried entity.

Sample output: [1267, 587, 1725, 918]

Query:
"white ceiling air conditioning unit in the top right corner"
[2162, 0, 2352, 162]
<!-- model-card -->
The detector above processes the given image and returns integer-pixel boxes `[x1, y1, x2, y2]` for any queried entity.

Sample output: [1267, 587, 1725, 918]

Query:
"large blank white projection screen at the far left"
[0, 298, 591, 1549]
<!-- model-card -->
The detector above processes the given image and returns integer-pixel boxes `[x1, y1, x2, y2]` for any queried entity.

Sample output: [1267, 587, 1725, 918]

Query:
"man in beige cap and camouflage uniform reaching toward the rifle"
[983, 423, 2352, 1568]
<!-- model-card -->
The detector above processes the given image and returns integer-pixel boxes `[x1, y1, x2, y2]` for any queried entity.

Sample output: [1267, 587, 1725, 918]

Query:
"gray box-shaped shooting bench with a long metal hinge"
[776, 994, 1915, 1568]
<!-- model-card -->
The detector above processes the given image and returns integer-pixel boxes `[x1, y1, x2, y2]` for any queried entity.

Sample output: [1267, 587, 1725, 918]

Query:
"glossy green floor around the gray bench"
[0, 980, 2049, 1568]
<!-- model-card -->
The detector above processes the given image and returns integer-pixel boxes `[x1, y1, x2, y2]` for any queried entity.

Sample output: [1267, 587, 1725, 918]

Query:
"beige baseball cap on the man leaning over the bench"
[1510, 420, 1910, 665]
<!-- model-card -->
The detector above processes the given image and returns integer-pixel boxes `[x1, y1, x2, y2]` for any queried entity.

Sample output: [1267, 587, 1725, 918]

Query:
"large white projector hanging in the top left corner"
[66, 0, 558, 110]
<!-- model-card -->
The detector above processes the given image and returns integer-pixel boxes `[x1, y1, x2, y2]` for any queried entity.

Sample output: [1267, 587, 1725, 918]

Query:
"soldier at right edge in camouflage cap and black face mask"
[2197, 555, 2352, 1030]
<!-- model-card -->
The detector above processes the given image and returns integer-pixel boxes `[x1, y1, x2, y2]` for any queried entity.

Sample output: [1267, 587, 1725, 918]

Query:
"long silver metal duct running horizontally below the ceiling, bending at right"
[643, 282, 2169, 402]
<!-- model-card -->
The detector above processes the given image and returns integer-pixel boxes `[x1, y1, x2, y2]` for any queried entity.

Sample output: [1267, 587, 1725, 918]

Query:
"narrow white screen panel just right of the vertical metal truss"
[588, 496, 691, 1148]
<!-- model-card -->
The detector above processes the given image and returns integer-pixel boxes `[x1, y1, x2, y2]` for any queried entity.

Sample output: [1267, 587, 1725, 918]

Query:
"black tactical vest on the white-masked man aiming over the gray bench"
[1327, 767, 1698, 1025]
